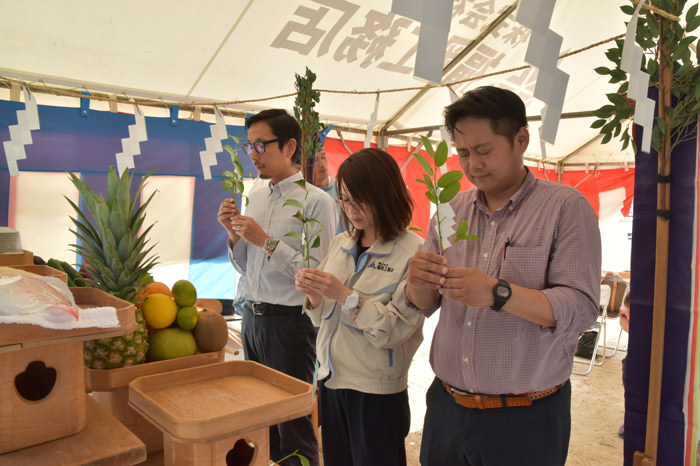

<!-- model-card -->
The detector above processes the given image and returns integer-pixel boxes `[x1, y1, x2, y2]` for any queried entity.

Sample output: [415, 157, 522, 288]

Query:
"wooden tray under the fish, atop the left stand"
[0, 288, 136, 352]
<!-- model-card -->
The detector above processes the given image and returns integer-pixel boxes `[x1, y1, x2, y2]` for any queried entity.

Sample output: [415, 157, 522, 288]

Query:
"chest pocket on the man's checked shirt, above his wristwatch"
[498, 246, 549, 290]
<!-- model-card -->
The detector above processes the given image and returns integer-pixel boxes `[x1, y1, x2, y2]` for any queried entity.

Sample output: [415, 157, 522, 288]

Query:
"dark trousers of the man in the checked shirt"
[420, 377, 571, 466]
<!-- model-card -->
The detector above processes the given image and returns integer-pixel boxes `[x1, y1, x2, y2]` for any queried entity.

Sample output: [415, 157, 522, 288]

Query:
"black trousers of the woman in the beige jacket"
[319, 381, 411, 466]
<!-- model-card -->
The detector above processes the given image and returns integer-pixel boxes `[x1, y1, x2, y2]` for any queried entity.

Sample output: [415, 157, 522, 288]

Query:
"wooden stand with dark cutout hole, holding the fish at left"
[0, 288, 135, 456]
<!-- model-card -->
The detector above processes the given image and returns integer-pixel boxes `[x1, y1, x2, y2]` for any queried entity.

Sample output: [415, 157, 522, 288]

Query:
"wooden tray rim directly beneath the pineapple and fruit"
[85, 351, 224, 392]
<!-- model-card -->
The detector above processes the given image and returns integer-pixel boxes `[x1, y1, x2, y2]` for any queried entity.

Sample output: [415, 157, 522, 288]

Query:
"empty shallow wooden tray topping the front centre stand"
[129, 361, 312, 442]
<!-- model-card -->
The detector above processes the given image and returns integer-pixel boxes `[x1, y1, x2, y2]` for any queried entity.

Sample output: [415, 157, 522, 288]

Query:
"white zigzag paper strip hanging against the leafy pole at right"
[620, 2, 654, 153]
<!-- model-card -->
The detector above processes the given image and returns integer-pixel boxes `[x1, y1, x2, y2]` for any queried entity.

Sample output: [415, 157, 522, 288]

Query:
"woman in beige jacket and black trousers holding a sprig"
[296, 149, 423, 466]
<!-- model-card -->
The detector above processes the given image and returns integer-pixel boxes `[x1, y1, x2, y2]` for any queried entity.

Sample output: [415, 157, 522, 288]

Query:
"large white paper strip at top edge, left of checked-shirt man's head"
[391, 0, 454, 84]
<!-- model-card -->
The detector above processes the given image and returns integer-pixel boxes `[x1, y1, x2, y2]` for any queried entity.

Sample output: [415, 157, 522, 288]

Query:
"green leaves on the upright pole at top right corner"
[591, 0, 700, 152]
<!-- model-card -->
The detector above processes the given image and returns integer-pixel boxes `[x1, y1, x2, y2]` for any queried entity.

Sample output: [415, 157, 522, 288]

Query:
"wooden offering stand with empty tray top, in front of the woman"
[129, 361, 312, 466]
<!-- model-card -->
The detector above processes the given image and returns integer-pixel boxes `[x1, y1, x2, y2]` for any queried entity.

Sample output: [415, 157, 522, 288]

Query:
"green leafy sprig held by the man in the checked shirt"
[414, 136, 479, 255]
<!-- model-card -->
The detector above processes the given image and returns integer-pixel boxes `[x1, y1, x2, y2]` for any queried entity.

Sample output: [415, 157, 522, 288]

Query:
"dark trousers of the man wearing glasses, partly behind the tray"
[241, 306, 319, 466]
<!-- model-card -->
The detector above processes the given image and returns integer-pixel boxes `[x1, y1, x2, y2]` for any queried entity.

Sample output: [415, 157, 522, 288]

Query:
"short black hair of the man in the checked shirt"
[445, 86, 527, 141]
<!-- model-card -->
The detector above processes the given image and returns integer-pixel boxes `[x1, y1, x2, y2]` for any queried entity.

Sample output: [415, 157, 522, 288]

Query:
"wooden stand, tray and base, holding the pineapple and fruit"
[85, 351, 224, 454]
